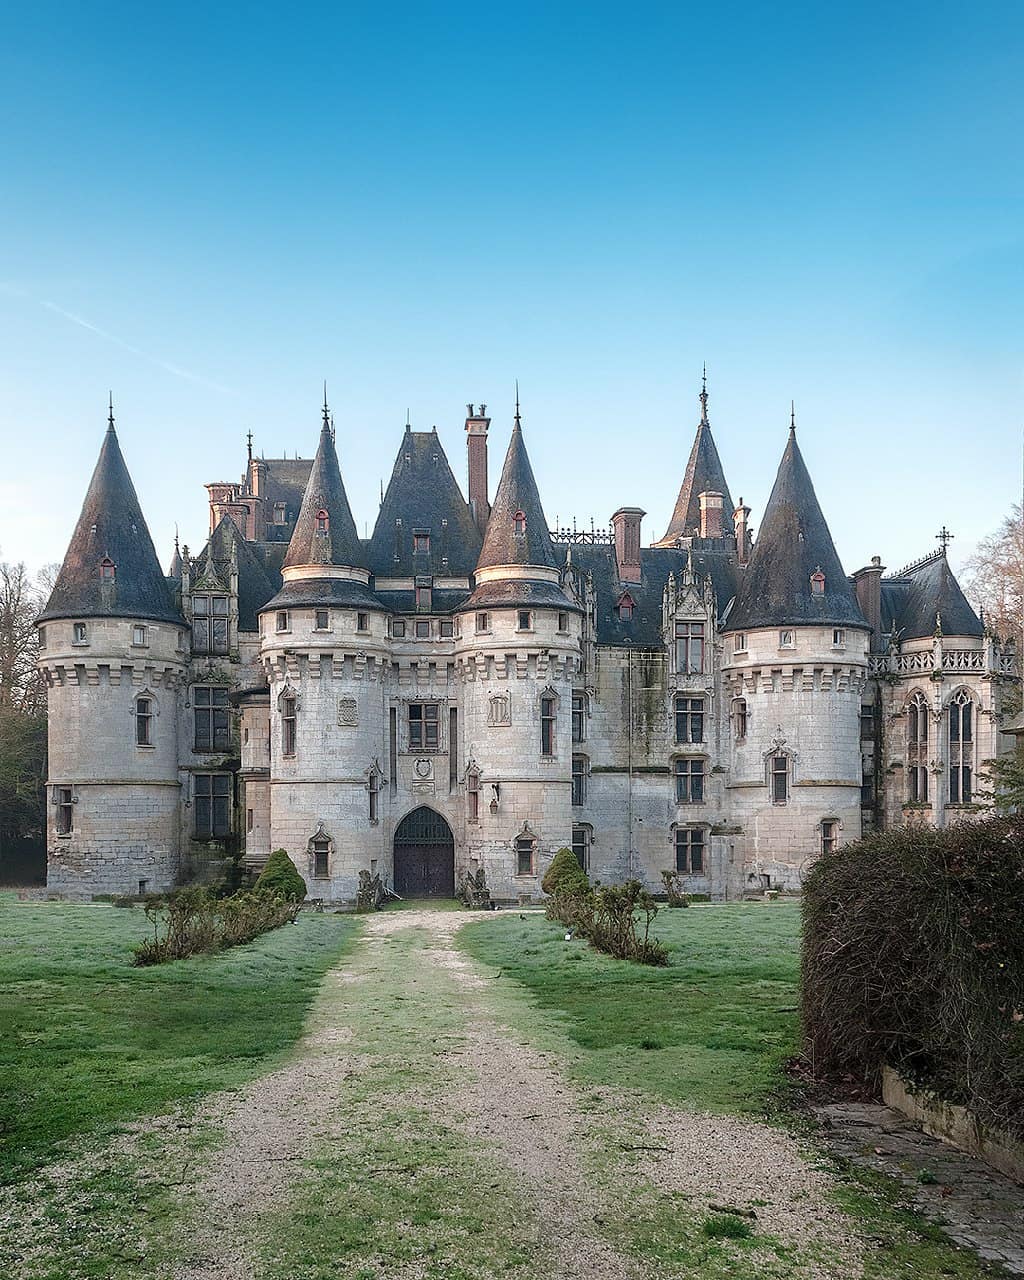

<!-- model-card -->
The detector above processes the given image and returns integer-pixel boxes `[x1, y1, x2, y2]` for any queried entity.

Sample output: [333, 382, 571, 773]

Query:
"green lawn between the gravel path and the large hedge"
[461, 902, 800, 1114]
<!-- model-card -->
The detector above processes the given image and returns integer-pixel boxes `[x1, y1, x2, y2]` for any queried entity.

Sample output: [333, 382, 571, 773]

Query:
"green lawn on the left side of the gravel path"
[0, 895, 358, 1181]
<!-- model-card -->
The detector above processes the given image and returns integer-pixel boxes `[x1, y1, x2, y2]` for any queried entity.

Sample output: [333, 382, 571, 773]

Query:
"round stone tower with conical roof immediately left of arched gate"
[260, 403, 388, 900]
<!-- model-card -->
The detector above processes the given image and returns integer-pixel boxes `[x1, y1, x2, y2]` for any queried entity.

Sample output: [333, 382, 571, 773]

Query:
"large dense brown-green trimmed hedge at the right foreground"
[803, 814, 1024, 1137]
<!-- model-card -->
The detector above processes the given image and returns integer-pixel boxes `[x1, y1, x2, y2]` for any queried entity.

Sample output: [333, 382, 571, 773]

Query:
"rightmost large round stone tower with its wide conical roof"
[722, 422, 870, 892]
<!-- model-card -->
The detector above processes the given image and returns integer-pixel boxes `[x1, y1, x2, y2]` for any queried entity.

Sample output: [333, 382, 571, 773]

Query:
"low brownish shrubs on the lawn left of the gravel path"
[134, 885, 305, 965]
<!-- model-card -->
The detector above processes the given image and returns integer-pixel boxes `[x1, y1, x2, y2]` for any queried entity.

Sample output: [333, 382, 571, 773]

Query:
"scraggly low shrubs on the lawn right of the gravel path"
[541, 875, 668, 965]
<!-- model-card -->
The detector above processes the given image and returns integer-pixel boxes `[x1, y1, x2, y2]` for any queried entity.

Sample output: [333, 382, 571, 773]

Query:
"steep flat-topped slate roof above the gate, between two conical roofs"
[370, 428, 480, 577]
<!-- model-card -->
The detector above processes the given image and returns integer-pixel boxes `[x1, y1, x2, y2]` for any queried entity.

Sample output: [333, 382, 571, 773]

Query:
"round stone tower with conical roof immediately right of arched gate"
[456, 404, 581, 899]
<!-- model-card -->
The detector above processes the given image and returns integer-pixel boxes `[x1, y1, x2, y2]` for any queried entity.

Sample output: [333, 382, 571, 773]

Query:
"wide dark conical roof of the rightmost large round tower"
[723, 429, 868, 631]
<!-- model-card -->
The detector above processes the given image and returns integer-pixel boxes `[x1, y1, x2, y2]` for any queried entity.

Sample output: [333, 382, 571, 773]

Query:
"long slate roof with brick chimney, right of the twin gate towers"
[568, 543, 737, 648]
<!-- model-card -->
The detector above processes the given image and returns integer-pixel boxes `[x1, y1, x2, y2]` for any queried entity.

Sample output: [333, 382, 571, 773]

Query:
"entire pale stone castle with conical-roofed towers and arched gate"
[38, 385, 1016, 902]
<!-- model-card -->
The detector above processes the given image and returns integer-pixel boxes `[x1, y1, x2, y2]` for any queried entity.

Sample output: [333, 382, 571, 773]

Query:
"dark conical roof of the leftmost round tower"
[40, 408, 183, 622]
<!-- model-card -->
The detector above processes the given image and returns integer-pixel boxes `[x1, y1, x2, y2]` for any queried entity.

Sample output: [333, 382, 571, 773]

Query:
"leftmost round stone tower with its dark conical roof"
[38, 404, 186, 896]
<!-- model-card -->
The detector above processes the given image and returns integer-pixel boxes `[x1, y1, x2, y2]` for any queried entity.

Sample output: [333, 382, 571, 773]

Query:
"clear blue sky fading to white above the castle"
[0, 0, 1024, 583]
